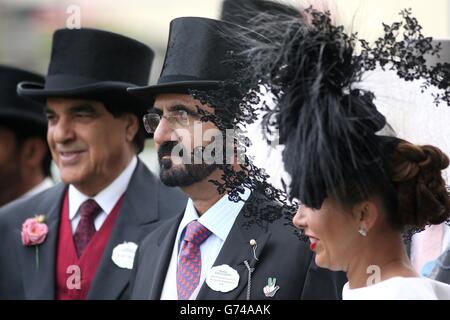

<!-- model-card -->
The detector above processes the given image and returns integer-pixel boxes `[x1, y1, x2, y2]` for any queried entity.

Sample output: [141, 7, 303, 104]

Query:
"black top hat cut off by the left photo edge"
[0, 65, 47, 127]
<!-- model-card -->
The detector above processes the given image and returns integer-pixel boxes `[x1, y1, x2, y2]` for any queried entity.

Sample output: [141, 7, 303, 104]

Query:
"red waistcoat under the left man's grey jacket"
[56, 191, 123, 300]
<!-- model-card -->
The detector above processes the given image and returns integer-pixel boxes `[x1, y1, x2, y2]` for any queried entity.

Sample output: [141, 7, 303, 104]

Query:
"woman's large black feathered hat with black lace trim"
[235, 9, 450, 208]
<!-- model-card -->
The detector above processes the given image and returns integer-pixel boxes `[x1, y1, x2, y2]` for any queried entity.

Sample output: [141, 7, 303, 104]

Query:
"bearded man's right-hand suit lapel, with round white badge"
[197, 192, 271, 300]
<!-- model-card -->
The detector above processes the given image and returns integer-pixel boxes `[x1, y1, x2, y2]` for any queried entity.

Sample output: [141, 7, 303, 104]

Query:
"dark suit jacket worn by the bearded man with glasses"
[131, 192, 347, 300]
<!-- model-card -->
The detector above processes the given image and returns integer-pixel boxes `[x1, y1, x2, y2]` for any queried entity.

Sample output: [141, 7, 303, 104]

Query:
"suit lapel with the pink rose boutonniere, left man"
[16, 184, 66, 300]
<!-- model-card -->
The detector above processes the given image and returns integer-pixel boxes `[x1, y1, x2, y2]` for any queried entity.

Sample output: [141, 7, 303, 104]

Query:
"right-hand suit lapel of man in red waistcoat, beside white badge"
[87, 161, 159, 300]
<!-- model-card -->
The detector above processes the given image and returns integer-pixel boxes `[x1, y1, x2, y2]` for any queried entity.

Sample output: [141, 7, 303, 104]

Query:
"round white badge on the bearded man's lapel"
[206, 264, 239, 293]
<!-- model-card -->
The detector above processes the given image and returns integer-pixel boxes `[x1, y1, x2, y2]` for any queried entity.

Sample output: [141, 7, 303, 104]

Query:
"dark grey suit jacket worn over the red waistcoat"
[0, 161, 187, 299]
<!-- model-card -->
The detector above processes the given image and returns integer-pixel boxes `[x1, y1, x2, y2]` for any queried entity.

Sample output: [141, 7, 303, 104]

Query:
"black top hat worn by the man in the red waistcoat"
[17, 29, 154, 112]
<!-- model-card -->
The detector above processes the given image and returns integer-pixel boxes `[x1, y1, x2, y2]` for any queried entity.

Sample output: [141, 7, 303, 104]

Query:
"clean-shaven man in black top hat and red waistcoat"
[0, 29, 185, 299]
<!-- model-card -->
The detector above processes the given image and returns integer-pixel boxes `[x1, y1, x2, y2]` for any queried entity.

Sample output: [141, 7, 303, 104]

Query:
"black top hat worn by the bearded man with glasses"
[128, 17, 241, 100]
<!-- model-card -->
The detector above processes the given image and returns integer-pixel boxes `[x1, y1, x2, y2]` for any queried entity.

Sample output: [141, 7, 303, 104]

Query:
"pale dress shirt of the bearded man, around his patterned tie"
[161, 189, 251, 300]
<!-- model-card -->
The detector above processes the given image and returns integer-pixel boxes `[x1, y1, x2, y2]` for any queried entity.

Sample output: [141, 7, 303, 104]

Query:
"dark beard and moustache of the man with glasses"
[158, 141, 217, 187]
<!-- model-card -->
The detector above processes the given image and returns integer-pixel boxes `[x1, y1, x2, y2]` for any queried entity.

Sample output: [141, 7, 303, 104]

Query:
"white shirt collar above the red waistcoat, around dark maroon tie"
[69, 156, 137, 233]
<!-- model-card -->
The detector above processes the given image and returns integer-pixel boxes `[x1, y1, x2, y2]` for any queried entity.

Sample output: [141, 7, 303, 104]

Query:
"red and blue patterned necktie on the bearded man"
[177, 221, 211, 300]
